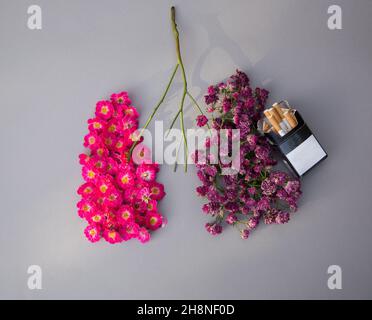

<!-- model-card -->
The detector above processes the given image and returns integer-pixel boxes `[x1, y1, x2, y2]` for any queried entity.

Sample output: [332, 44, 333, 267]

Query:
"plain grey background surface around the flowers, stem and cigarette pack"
[0, 0, 372, 299]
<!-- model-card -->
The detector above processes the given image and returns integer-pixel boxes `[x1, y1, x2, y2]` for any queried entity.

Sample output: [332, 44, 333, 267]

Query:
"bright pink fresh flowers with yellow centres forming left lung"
[77, 92, 166, 243]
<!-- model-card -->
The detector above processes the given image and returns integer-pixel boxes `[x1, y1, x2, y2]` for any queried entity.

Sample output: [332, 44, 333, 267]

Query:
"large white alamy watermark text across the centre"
[132, 121, 242, 175]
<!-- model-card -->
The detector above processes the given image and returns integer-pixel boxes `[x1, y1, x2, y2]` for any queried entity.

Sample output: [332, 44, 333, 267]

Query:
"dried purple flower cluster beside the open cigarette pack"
[196, 71, 301, 239]
